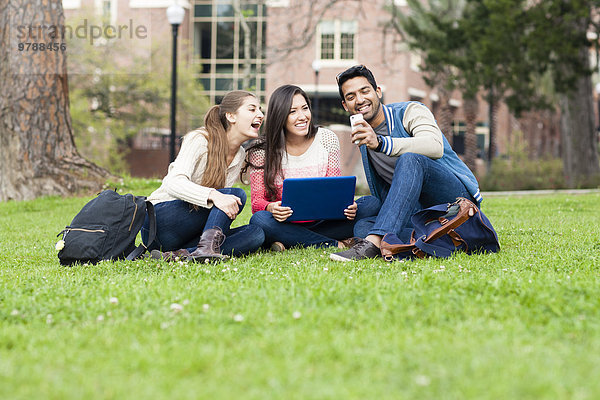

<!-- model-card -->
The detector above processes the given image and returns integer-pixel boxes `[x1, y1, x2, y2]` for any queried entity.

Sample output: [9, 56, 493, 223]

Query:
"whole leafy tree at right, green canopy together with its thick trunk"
[392, 0, 600, 186]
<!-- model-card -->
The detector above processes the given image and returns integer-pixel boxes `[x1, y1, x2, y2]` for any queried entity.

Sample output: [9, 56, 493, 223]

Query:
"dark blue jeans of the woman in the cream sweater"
[141, 188, 265, 256]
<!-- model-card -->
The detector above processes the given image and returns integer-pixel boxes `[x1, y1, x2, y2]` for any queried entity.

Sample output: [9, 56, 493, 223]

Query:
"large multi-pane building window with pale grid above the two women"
[192, 0, 267, 103]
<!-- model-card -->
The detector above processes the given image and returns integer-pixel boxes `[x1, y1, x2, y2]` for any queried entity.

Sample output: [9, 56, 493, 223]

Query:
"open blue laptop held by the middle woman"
[281, 176, 356, 221]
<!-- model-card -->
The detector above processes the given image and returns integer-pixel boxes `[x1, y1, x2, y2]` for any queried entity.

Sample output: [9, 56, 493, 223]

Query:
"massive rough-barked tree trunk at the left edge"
[0, 0, 110, 201]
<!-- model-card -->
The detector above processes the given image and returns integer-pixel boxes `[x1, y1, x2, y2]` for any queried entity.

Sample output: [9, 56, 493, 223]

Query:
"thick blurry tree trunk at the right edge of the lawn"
[560, 48, 600, 188]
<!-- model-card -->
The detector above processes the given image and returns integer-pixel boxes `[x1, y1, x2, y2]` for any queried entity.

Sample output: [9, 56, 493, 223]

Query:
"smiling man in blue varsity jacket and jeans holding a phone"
[330, 65, 482, 261]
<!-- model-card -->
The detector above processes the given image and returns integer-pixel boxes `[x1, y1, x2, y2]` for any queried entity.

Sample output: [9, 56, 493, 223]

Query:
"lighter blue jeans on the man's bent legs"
[361, 153, 477, 242]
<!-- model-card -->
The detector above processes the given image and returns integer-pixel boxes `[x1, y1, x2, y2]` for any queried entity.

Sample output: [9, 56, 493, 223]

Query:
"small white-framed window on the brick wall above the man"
[317, 20, 357, 60]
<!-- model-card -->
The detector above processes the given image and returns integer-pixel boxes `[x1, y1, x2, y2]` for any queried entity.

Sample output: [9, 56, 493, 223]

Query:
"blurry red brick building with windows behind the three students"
[63, 0, 514, 178]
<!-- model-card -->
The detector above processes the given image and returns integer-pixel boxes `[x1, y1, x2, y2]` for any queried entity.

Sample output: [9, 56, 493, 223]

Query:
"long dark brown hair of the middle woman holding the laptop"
[244, 85, 317, 200]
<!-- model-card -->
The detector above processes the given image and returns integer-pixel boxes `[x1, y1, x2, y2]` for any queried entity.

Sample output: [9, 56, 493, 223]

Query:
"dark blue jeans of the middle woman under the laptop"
[250, 196, 381, 247]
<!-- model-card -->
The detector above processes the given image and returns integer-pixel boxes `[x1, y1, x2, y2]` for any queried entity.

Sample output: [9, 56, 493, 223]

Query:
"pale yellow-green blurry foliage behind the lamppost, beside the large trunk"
[68, 13, 209, 173]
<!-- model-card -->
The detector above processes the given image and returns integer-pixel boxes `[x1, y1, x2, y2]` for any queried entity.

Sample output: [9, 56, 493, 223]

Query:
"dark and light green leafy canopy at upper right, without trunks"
[392, 0, 598, 114]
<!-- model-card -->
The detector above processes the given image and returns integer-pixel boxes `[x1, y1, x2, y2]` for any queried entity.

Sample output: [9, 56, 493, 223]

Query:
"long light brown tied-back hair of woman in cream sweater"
[202, 90, 256, 189]
